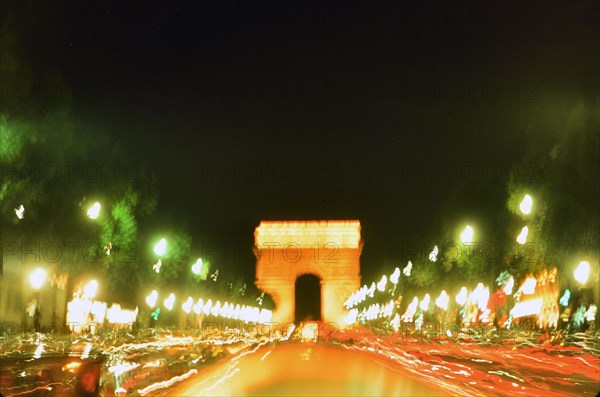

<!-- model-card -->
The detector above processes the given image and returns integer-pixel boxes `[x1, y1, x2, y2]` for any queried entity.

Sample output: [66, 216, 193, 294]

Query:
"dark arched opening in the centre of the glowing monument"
[294, 274, 322, 324]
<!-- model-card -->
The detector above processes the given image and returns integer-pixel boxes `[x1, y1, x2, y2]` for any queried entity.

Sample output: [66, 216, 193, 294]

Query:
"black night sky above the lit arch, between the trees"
[7, 0, 599, 279]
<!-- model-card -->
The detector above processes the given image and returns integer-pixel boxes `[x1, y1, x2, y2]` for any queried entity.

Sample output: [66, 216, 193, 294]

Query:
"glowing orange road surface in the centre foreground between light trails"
[166, 343, 450, 397]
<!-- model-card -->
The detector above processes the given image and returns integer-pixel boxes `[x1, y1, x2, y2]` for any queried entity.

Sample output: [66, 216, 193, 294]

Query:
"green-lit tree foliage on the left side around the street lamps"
[0, 12, 157, 304]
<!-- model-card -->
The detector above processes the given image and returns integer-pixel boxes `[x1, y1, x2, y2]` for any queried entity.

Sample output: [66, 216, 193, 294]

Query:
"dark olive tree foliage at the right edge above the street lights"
[507, 99, 600, 276]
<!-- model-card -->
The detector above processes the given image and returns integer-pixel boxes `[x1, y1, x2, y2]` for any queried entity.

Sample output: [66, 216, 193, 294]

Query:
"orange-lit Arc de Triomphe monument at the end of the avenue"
[254, 220, 362, 327]
